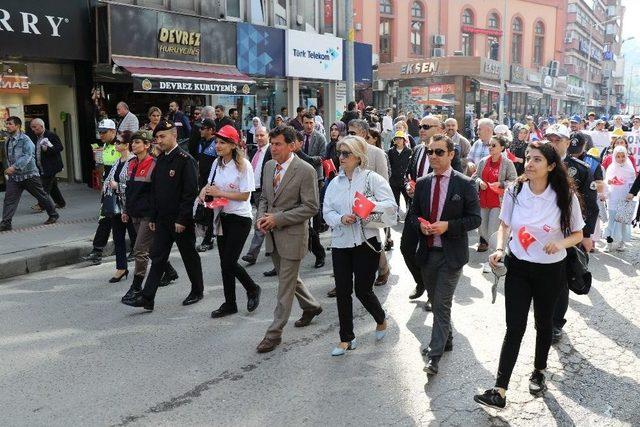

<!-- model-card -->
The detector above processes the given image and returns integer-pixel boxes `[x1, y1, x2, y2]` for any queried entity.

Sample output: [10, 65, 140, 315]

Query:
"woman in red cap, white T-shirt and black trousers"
[200, 125, 260, 318]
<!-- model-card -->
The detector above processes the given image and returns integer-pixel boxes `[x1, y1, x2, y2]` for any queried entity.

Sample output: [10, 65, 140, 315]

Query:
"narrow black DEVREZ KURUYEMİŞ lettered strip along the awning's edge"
[133, 77, 255, 95]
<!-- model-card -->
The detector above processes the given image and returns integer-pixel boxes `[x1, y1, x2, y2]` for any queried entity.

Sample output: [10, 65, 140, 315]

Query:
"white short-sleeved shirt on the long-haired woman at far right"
[500, 182, 585, 264]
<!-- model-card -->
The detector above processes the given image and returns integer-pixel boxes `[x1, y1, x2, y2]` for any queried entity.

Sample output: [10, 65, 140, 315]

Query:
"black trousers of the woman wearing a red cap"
[216, 214, 258, 308]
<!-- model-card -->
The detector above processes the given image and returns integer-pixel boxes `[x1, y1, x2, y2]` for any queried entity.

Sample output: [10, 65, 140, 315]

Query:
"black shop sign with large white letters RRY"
[0, 0, 91, 60]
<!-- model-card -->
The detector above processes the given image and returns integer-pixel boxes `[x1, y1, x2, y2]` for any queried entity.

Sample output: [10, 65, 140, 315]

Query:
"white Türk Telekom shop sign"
[286, 30, 344, 80]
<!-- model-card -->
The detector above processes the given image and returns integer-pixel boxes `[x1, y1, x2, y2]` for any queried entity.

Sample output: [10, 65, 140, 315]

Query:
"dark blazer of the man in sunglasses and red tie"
[405, 170, 480, 269]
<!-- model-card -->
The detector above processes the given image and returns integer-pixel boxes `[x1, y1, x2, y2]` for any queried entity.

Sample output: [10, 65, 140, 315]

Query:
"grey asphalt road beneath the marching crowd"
[0, 226, 640, 426]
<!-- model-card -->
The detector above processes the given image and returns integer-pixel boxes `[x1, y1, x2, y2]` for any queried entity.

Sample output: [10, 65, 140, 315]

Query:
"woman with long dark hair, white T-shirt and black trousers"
[474, 141, 584, 408]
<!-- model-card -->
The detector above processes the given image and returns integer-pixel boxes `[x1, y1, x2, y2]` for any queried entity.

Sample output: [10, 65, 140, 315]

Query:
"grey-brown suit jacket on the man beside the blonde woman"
[257, 154, 320, 260]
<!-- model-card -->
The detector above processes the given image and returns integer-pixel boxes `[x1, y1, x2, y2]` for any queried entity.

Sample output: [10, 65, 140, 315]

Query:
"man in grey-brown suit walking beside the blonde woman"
[256, 126, 322, 353]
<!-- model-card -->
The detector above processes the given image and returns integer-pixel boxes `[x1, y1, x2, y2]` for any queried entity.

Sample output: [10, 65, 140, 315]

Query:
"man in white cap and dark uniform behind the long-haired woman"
[545, 124, 599, 343]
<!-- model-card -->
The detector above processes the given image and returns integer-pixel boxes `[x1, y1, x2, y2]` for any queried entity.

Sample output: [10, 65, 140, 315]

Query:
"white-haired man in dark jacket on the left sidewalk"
[28, 119, 67, 212]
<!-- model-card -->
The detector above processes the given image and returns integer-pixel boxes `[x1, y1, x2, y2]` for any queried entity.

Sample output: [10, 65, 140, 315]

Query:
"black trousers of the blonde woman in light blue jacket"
[331, 237, 385, 342]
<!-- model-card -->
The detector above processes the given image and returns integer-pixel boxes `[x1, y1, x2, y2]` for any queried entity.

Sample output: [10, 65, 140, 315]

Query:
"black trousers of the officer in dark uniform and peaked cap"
[142, 218, 204, 300]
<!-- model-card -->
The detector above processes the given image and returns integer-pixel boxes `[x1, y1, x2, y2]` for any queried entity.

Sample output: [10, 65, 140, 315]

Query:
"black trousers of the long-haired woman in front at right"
[496, 255, 566, 389]
